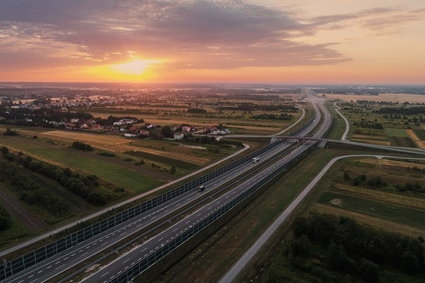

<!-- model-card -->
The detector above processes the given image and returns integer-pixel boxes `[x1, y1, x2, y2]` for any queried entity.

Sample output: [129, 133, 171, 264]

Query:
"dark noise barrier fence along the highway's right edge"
[111, 142, 316, 283]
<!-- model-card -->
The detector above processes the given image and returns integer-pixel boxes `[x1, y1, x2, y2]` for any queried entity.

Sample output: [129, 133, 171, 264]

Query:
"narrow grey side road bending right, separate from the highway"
[219, 154, 424, 283]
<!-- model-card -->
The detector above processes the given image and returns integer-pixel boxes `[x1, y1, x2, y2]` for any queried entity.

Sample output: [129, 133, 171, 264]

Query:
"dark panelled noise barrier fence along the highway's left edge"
[0, 141, 288, 280]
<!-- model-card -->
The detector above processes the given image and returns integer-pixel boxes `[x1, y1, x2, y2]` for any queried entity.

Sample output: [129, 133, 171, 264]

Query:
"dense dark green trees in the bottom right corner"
[289, 214, 425, 282]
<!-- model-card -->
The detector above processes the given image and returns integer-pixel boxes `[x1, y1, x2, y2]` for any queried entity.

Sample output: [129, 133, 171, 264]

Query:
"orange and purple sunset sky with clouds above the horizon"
[0, 0, 425, 84]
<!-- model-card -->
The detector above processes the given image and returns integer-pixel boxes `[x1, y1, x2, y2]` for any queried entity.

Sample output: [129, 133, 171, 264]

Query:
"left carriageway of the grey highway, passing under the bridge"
[2, 96, 320, 283]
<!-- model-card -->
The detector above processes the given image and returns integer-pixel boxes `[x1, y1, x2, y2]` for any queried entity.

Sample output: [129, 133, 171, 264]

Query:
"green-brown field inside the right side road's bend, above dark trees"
[313, 158, 425, 235]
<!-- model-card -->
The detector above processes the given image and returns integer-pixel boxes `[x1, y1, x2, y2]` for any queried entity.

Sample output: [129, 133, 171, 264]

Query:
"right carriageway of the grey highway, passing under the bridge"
[83, 94, 332, 282]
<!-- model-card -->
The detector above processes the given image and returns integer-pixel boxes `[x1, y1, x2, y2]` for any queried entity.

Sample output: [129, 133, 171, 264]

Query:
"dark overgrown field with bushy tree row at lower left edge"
[0, 151, 125, 248]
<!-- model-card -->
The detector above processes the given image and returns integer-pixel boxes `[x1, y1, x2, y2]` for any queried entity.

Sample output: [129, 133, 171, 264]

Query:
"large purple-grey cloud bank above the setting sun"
[0, 0, 347, 69]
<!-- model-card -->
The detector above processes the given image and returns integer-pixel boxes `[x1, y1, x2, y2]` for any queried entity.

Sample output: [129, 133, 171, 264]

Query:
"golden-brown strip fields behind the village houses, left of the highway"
[82, 96, 301, 134]
